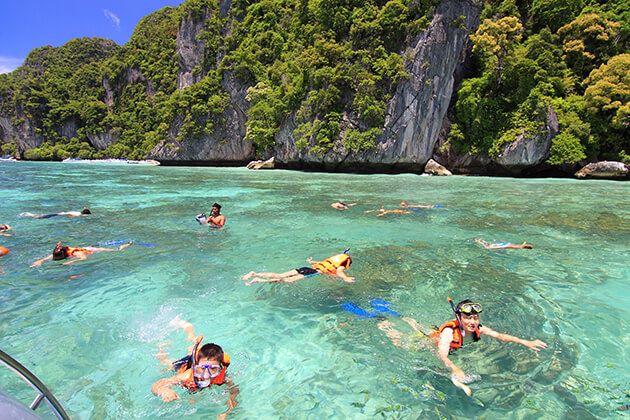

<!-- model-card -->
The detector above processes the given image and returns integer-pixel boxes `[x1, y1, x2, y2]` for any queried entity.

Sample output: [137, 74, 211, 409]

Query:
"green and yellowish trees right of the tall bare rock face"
[451, 0, 630, 165]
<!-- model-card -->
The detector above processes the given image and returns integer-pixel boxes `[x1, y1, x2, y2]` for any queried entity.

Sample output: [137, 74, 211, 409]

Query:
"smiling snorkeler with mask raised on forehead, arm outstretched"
[379, 298, 547, 396]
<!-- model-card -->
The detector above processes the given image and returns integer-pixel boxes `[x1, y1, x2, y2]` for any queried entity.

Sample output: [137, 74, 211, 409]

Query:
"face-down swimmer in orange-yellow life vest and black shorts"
[241, 249, 354, 286]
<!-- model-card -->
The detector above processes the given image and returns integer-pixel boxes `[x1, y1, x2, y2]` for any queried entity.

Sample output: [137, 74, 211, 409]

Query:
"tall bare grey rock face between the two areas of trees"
[274, 0, 479, 171]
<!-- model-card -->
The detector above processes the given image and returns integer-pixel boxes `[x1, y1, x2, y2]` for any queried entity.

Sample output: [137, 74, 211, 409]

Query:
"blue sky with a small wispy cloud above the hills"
[0, 0, 183, 73]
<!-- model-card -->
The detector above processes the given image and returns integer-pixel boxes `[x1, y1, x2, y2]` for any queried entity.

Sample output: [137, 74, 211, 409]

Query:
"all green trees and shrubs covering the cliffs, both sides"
[0, 0, 630, 165]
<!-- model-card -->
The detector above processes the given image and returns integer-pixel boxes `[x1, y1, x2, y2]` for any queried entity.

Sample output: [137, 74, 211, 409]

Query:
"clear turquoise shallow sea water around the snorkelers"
[0, 163, 630, 419]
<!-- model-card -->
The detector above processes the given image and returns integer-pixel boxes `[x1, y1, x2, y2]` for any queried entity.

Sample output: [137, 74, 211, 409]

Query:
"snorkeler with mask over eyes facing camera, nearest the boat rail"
[151, 318, 240, 419]
